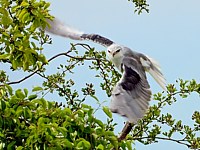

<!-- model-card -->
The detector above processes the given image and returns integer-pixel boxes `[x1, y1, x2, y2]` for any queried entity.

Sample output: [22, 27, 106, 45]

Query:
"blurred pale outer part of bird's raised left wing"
[45, 18, 83, 40]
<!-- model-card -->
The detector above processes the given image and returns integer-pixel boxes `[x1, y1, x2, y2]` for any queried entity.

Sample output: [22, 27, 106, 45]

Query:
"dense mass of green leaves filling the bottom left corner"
[0, 85, 118, 150]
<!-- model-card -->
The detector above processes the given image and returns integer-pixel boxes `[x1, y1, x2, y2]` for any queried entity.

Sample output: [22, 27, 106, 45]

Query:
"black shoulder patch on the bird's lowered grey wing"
[121, 65, 141, 91]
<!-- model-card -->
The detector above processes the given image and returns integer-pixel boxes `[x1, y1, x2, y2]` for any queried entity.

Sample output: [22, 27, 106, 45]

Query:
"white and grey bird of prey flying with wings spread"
[45, 18, 166, 124]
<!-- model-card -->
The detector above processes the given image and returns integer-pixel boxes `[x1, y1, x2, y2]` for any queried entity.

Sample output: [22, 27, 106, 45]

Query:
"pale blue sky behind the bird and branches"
[1, 0, 200, 150]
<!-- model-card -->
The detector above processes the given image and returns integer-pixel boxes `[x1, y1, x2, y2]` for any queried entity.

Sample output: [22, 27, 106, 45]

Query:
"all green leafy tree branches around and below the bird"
[0, 0, 200, 150]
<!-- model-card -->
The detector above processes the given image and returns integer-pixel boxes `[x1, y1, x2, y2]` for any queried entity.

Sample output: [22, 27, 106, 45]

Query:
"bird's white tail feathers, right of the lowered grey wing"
[141, 56, 166, 91]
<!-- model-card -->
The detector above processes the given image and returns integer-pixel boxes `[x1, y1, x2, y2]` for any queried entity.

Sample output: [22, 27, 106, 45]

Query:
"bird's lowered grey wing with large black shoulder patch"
[110, 57, 151, 123]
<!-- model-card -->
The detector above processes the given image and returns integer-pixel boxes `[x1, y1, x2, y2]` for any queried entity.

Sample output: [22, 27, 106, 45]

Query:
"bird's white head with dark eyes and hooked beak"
[107, 44, 123, 61]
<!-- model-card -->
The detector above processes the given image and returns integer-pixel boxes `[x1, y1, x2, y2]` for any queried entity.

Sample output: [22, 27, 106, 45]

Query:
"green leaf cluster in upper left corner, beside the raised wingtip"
[0, 0, 52, 70]
